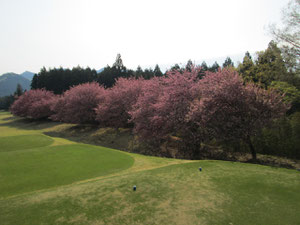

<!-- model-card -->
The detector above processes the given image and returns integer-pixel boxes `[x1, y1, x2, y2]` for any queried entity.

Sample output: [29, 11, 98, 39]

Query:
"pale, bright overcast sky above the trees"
[0, 0, 289, 74]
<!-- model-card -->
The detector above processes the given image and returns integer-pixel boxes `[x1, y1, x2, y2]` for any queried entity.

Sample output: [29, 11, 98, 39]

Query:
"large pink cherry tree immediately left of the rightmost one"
[129, 68, 199, 151]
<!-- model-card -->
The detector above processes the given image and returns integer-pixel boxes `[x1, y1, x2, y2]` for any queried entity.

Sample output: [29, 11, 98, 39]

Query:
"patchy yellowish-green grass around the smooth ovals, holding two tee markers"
[0, 111, 300, 224]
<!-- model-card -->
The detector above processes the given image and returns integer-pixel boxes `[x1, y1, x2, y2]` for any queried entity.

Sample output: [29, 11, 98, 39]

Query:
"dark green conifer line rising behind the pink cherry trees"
[31, 54, 233, 94]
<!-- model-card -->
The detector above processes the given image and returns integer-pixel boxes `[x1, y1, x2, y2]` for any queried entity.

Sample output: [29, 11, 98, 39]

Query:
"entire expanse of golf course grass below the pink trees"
[0, 113, 300, 225]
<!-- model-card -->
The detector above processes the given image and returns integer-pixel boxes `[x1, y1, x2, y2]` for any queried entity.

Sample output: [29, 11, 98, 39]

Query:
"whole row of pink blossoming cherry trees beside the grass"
[11, 67, 289, 159]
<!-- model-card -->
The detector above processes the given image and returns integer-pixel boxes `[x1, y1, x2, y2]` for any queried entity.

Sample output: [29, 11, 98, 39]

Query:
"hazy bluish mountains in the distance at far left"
[0, 73, 31, 97]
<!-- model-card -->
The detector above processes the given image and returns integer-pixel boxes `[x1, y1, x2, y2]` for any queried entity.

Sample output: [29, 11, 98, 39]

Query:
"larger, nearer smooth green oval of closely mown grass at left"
[0, 144, 134, 197]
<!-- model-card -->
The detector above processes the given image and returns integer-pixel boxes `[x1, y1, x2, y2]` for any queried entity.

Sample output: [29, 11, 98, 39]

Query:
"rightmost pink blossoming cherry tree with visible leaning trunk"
[187, 69, 289, 160]
